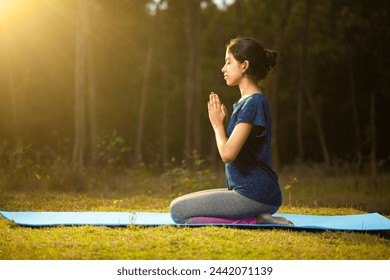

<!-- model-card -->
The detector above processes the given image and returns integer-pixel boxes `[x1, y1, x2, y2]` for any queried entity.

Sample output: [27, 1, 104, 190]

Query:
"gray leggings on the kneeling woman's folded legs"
[171, 188, 279, 224]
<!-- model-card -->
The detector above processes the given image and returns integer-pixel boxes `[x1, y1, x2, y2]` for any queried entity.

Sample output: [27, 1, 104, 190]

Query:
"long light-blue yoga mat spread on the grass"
[0, 211, 390, 231]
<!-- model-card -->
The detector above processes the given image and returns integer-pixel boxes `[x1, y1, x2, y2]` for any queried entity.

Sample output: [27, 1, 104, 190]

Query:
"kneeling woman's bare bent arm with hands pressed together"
[208, 93, 253, 162]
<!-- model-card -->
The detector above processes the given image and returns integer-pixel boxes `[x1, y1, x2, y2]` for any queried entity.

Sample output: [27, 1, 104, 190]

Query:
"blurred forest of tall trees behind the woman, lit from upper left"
[0, 0, 390, 213]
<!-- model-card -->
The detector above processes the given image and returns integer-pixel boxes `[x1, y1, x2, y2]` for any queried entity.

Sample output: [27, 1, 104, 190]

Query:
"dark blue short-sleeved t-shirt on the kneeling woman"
[225, 93, 282, 206]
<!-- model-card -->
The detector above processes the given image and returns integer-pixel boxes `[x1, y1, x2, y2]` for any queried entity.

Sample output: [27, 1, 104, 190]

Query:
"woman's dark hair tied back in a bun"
[226, 37, 278, 82]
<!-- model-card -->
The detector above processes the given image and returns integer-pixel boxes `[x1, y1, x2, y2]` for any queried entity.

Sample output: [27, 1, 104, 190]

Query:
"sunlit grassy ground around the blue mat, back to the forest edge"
[0, 163, 390, 260]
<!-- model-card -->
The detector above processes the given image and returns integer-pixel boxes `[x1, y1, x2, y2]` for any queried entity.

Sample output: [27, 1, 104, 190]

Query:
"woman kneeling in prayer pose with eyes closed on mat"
[170, 38, 291, 224]
